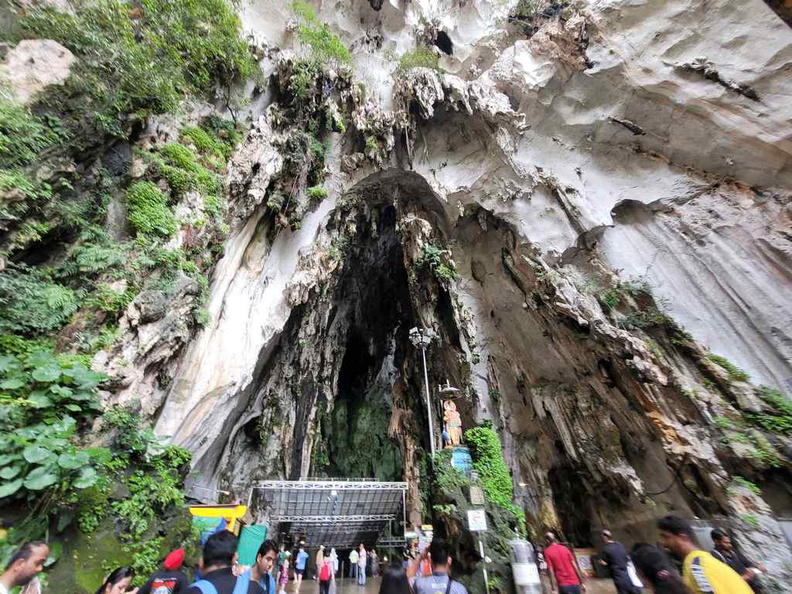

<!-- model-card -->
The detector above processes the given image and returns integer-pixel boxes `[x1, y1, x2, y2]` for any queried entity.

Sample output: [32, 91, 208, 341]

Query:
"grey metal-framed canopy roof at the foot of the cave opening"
[250, 479, 407, 548]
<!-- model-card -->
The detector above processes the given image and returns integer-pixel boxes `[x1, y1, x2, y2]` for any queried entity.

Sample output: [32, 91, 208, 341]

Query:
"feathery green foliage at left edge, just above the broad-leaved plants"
[0, 264, 82, 334]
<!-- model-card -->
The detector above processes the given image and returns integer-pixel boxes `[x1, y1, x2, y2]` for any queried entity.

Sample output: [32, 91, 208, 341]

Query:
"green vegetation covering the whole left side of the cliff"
[0, 0, 252, 580]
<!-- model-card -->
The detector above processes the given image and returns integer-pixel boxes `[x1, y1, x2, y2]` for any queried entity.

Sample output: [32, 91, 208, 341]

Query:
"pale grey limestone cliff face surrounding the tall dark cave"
[96, 0, 792, 577]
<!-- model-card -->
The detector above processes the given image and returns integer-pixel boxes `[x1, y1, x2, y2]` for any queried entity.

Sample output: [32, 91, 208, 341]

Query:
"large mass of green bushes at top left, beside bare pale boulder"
[22, 0, 256, 136]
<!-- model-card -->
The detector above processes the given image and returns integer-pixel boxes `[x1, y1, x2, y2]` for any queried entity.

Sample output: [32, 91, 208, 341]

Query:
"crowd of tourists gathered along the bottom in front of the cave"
[0, 516, 765, 594]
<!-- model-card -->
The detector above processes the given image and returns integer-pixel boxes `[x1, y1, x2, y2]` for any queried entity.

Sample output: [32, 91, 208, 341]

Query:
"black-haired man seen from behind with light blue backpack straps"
[185, 530, 264, 594]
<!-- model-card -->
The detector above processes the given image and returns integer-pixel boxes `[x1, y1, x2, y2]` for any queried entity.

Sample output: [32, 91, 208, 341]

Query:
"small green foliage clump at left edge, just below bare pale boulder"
[0, 99, 59, 169]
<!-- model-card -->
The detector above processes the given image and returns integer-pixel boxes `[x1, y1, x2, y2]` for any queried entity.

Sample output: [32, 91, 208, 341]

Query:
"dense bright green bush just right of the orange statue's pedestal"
[465, 426, 525, 526]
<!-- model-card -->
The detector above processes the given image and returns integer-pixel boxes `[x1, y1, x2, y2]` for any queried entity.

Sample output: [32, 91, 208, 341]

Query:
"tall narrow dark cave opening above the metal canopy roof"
[313, 204, 413, 481]
